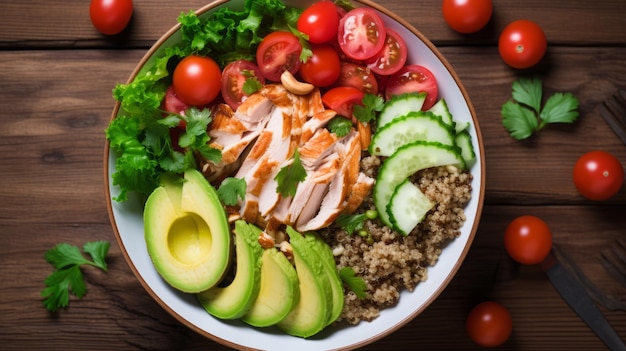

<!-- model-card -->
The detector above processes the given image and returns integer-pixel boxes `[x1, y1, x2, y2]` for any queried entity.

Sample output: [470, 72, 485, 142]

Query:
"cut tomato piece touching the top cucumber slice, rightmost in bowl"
[385, 65, 439, 110]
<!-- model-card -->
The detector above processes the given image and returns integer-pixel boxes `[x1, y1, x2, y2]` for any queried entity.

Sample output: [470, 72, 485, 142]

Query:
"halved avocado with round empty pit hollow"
[143, 170, 231, 293]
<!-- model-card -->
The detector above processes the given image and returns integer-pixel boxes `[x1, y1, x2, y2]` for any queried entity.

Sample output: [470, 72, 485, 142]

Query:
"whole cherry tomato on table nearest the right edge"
[573, 150, 624, 201]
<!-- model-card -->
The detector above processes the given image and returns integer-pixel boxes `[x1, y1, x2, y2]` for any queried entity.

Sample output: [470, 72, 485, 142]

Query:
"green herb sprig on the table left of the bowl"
[41, 241, 110, 312]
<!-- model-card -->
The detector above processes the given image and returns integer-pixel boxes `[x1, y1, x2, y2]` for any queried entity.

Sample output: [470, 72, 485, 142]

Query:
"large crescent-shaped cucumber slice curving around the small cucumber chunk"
[374, 141, 465, 228]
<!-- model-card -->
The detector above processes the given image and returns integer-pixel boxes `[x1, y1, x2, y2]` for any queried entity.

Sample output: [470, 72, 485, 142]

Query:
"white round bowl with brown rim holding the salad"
[104, 0, 485, 351]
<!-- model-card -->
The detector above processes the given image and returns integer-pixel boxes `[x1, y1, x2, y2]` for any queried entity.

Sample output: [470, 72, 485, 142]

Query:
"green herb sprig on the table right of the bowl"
[500, 78, 579, 140]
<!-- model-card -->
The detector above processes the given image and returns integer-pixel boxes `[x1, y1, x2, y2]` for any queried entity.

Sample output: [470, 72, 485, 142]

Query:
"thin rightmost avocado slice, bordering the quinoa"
[305, 232, 344, 325]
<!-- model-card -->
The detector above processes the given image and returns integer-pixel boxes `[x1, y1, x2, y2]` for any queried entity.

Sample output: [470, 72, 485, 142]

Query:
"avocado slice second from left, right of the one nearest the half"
[241, 247, 300, 327]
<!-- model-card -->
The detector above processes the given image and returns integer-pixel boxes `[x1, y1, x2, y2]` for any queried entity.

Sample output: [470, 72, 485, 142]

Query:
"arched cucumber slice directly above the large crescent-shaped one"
[369, 111, 455, 156]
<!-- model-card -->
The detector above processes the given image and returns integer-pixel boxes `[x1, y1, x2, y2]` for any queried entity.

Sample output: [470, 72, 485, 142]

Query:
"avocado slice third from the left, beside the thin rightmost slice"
[276, 227, 332, 338]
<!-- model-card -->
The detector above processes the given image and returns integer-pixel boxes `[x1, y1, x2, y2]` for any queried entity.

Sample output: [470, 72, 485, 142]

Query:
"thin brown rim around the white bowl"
[103, 0, 486, 350]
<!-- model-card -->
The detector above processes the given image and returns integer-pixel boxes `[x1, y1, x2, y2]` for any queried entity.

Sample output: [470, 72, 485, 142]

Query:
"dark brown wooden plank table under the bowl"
[0, 0, 626, 350]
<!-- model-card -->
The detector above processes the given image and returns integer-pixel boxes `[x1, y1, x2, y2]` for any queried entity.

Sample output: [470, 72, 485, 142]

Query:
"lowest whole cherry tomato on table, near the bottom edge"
[465, 301, 513, 347]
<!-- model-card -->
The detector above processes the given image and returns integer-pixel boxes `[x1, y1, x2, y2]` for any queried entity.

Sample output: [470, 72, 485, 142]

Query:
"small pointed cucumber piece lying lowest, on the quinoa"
[387, 179, 435, 236]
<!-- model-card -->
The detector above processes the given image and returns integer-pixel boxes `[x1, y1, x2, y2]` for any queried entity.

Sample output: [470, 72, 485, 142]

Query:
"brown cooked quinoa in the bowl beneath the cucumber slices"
[324, 156, 472, 324]
